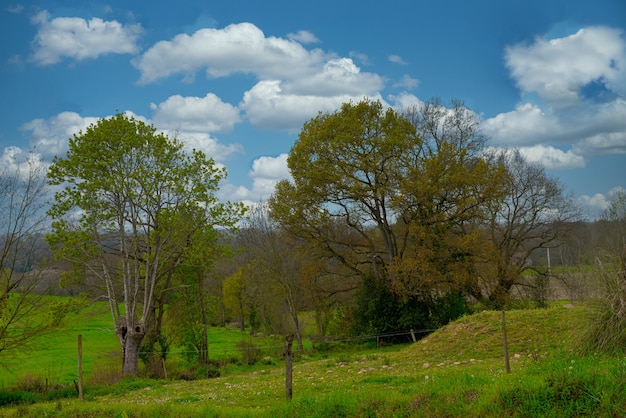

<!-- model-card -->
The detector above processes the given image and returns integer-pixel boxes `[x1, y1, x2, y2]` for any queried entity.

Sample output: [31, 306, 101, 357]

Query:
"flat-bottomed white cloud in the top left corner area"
[31, 11, 142, 65]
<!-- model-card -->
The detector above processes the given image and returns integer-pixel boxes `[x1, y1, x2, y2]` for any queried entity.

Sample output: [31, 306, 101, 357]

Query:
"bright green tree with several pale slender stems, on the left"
[48, 114, 243, 375]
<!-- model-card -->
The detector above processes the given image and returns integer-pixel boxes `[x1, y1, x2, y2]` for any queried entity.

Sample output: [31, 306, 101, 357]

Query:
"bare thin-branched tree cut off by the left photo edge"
[0, 155, 72, 354]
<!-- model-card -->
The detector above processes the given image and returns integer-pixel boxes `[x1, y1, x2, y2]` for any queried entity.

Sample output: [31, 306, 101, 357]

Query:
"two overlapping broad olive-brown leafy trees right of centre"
[269, 100, 505, 332]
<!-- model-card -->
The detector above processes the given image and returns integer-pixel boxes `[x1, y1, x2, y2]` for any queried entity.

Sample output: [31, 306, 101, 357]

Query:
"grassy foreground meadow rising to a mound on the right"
[0, 306, 626, 418]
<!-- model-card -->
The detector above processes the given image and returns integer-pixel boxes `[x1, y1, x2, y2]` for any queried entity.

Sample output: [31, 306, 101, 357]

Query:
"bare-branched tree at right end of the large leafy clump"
[483, 151, 580, 308]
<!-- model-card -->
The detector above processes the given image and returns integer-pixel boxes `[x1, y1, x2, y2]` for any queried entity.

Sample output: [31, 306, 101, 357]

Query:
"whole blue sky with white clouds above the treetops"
[0, 0, 626, 216]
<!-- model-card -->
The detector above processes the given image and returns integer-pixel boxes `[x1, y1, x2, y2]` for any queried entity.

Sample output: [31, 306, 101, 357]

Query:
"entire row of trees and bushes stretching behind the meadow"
[0, 100, 626, 375]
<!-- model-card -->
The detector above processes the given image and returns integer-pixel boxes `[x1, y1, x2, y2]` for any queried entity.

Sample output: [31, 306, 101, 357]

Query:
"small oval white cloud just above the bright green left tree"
[151, 93, 241, 132]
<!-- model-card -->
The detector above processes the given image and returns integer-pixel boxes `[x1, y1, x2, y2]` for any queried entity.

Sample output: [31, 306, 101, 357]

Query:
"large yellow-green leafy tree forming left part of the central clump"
[269, 100, 421, 277]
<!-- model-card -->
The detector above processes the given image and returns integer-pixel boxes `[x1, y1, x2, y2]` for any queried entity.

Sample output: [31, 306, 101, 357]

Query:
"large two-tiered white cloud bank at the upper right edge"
[482, 27, 626, 168]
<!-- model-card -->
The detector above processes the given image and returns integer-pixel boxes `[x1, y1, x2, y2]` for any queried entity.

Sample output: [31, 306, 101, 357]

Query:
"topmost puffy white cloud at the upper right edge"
[505, 27, 626, 106]
